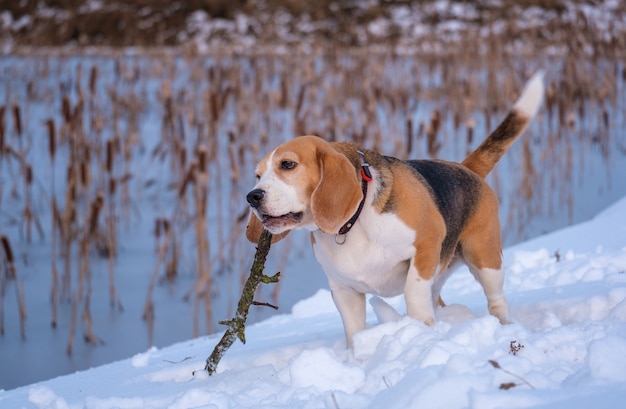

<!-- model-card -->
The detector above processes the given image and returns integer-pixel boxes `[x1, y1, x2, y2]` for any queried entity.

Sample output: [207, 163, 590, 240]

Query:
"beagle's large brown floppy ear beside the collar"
[311, 149, 363, 234]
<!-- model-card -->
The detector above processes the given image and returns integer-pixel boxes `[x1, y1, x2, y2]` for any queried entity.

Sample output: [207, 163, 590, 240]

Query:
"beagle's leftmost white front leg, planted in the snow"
[329, 280, 365, 348]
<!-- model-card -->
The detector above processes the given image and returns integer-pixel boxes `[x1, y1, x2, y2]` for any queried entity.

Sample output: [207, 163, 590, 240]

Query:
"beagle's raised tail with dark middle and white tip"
[463, 72, 544, 178]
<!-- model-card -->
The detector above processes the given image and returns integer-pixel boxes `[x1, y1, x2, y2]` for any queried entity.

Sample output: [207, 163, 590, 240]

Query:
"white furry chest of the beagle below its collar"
[313, 212, 415, 296]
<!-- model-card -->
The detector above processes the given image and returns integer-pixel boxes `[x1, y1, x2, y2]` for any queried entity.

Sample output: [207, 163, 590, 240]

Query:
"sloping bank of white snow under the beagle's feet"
[0, 198, 626, 409]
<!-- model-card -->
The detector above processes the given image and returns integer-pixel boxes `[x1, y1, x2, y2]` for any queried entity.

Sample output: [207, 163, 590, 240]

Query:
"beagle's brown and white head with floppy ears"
[246, 136, 363, 242]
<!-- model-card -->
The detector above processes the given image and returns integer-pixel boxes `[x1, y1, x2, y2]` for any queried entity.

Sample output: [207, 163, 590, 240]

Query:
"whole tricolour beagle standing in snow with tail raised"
[246, 74, 544, 348]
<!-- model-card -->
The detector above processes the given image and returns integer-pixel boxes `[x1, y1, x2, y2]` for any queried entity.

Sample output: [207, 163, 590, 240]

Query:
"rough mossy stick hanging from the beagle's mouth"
[204, 230, 280, 375]
